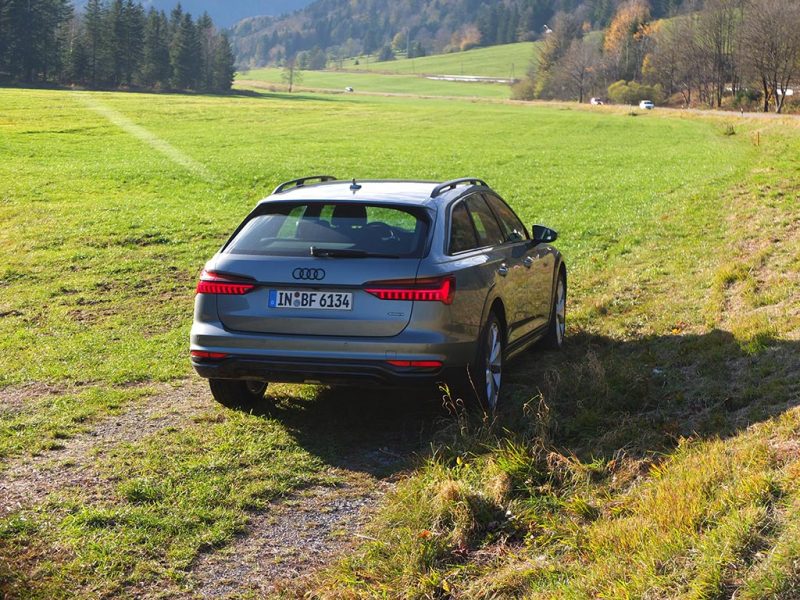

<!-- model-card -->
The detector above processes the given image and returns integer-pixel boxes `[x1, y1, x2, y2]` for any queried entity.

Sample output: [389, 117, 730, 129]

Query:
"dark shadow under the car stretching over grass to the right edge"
[222, 330, 800, 477]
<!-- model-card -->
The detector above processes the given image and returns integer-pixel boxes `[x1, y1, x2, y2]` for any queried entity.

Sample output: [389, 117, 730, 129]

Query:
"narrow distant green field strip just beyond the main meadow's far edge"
[236, 67, 511, 100]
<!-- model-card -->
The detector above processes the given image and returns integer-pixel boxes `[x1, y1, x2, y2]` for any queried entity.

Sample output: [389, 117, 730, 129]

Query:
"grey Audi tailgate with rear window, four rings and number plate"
[213, 201, 430, 337]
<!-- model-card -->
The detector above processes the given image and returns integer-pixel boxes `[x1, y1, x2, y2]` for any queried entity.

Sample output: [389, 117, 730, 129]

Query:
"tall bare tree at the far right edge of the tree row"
[740, 0, 800, 113]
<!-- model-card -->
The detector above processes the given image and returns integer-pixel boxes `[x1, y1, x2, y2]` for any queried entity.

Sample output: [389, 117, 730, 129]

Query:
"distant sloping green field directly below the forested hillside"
[334, 42, 537, 79]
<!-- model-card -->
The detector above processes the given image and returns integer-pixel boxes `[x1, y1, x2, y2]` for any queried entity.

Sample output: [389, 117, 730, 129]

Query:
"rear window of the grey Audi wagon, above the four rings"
[223, 202, 429, 258]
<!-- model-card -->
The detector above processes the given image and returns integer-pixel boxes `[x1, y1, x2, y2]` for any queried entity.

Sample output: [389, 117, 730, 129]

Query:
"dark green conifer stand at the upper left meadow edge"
[0, 0, 235, 92]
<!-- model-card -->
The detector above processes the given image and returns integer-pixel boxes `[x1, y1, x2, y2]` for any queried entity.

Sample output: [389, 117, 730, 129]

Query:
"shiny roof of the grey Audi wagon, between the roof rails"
[259, 179, 488, 206]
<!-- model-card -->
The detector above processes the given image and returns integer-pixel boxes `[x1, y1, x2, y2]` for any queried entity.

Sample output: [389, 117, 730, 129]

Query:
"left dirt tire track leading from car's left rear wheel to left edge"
[0, 380, 210, 518]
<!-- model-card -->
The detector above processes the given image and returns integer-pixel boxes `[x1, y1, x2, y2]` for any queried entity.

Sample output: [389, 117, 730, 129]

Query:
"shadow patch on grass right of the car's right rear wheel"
[510, 330, 800, 460]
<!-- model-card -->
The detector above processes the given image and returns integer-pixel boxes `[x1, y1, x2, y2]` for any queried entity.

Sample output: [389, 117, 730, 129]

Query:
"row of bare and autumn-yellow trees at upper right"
[515, 0, 800, 113]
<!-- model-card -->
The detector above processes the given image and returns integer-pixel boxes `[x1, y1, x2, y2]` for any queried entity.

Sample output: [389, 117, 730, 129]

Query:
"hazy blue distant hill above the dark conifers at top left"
[74, 0, 311, 27]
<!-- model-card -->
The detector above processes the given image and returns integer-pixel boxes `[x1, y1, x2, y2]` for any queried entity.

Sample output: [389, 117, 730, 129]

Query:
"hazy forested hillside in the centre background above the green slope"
[233, 0, 688, 66]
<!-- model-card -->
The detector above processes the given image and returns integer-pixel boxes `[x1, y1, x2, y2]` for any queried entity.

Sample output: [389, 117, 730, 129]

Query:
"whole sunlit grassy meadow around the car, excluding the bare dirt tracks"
[0, 83, 800, 598]
